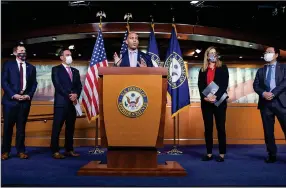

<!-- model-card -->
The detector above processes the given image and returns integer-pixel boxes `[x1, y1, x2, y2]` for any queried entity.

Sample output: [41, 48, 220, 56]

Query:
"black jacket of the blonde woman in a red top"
[198, 65, 229, 104]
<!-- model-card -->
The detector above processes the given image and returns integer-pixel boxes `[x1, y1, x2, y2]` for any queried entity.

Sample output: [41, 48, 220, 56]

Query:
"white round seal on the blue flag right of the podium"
[164, 52, 187, 89]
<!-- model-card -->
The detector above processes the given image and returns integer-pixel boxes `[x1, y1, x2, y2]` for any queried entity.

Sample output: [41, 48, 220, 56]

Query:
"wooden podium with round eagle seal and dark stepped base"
[78, 67, 187, 176]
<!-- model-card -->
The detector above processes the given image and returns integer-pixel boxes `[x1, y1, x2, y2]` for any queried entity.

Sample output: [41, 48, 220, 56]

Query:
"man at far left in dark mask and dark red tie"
[1, 45, 38, 160]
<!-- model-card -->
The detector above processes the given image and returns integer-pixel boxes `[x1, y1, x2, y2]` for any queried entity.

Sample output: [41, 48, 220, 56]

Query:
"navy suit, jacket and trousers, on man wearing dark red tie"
[1, 60, 38, 153]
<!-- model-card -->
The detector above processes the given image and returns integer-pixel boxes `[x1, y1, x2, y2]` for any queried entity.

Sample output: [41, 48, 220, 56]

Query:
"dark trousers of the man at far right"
[260, 99, 286, 155]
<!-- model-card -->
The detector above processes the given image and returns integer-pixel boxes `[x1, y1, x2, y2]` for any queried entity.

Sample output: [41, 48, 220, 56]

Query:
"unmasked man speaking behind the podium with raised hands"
[113, 32, 153, 67]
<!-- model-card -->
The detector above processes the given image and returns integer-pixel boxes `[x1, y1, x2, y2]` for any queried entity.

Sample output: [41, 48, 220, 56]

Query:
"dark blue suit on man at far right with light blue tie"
[253, 62, 286, 155]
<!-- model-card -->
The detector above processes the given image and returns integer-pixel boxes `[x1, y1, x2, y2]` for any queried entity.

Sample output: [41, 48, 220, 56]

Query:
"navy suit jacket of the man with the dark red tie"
[1, 60, 38, 105]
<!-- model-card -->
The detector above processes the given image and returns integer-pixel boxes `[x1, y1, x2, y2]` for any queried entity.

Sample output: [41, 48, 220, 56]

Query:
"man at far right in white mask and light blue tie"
[253, 47, 286, 163]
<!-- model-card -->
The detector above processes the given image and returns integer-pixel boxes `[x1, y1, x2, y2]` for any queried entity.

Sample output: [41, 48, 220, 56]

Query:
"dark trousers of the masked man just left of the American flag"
[51, 104, 76, 153]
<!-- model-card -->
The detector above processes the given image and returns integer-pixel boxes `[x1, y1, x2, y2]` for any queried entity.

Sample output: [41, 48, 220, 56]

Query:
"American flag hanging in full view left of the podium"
[82, 29, 108, 122]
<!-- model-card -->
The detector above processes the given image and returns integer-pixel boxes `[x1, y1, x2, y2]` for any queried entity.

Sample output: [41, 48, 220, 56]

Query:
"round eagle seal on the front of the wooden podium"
[117, 86, 148, 118]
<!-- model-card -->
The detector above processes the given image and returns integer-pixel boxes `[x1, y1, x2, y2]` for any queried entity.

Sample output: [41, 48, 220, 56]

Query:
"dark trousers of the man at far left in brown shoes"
[2, 101, 30, 153]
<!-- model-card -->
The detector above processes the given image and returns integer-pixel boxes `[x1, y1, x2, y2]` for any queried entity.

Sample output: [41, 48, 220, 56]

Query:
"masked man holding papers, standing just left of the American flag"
[51, 50, 82, 159]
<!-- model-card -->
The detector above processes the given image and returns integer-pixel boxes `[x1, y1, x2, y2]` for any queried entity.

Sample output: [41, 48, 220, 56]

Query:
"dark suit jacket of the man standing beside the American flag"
[52, 64, 82, 107]
